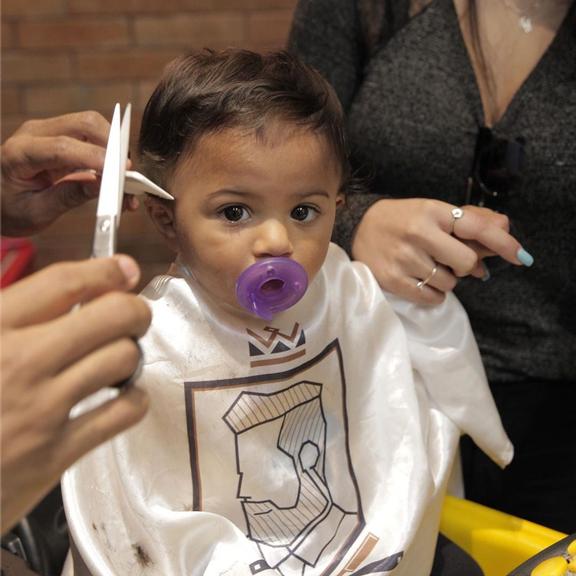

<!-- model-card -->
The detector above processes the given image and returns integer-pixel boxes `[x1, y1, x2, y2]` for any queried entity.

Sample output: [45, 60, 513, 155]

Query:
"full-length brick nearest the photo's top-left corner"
[18, 18, 129, 48]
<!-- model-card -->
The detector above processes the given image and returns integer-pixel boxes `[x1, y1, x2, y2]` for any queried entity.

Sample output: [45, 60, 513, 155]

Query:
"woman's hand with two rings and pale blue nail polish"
[352, 198, 529, 304]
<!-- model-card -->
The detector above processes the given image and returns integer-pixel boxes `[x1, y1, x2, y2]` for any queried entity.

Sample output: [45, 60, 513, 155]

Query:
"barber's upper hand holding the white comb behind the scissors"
[2, 112, 137, 236]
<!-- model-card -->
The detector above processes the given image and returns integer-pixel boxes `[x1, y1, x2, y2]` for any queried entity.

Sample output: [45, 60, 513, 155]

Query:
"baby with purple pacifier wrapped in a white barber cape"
[64, 50, 512, 576]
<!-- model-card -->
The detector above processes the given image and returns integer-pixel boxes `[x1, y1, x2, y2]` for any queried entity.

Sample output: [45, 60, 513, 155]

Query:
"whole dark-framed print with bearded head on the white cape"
[185, 340, 364, 576]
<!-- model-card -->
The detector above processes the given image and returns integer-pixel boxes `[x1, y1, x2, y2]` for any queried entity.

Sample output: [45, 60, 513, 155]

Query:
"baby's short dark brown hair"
[138, 49, 350, 188]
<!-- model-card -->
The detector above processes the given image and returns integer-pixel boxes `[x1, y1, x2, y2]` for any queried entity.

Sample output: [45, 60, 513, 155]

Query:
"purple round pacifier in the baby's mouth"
[236, 256, 308, 320]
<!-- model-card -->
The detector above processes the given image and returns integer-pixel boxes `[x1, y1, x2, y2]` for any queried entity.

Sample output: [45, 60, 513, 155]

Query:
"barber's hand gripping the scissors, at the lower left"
[0, 256, 151, 533]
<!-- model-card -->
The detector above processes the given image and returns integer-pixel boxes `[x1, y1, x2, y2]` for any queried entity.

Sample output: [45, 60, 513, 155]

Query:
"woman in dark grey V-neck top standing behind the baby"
[290, 0, 576, 533]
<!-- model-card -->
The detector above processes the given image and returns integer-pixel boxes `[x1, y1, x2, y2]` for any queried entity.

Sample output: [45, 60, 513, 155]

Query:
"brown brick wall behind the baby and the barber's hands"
[1, 0, 296, 286]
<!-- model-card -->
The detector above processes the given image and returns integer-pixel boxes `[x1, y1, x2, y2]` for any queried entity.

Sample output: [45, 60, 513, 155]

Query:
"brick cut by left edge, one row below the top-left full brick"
[2, 52, 71, 83]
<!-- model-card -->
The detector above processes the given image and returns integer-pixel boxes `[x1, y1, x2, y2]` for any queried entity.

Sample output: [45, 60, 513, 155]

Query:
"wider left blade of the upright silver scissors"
[93, 104, 123, 258]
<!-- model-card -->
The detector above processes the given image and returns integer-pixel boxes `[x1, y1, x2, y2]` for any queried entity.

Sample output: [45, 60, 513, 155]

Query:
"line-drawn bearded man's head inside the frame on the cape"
[224, 381, 332, 547]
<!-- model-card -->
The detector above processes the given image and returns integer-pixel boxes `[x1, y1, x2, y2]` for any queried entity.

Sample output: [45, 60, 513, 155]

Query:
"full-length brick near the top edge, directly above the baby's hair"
[134, 12, 245, 49]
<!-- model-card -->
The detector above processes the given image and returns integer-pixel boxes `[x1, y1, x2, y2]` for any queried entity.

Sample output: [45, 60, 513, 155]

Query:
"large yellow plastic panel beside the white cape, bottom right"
[440, 496, 566, 576]
